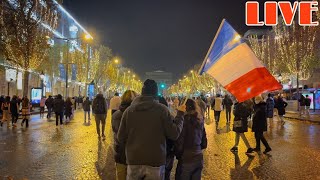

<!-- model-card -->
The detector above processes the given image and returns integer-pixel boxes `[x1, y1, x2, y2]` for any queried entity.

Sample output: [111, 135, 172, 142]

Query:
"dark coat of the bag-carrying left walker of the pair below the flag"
[233, 102, 251, 133]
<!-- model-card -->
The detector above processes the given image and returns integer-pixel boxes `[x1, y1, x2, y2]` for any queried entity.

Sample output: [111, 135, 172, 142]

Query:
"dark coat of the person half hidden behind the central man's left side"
[111, 103, 131, 164]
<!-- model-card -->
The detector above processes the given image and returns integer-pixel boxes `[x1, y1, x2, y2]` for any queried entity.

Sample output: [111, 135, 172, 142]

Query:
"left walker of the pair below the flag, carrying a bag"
[231, 100, 253, 154]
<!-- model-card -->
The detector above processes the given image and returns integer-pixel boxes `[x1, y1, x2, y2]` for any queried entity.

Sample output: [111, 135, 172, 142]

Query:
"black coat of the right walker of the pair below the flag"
[252, 102, 268, 132]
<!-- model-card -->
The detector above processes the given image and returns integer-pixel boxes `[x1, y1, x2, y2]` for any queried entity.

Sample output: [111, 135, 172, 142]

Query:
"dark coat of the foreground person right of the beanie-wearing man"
[174, 112, 207, 163]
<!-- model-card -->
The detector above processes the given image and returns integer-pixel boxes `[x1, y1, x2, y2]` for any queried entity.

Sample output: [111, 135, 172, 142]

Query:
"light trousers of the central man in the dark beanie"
[127, 165, 165, 180]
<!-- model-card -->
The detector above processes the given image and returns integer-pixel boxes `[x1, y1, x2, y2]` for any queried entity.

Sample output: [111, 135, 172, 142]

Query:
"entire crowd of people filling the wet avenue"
[0, 79, 300, 180]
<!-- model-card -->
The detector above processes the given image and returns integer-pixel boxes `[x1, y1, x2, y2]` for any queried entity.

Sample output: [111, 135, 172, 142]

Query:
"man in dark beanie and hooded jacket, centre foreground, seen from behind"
[117, 79, 185, 180]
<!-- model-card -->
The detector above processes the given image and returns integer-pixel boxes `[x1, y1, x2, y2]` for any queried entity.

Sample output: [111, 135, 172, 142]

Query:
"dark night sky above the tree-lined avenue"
[63, 0, 264, 80]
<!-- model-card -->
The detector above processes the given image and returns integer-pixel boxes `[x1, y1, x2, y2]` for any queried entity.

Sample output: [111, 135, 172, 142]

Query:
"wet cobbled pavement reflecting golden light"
[0, 110, 320, 180]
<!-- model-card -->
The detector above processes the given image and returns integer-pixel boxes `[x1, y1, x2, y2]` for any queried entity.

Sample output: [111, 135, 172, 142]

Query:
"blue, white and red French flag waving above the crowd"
[199, 19, 282, 102]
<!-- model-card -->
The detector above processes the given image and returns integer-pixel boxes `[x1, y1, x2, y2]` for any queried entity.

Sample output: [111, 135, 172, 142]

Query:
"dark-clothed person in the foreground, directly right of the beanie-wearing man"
[175, 99, 207, 180]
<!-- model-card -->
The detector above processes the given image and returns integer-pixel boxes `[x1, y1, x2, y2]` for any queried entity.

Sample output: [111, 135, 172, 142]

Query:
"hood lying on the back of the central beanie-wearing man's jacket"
[131, 95, 158, 111]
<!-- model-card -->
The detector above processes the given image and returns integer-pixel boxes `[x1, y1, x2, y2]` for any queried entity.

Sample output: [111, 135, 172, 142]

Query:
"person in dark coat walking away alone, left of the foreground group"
[92, 93, 108, 140]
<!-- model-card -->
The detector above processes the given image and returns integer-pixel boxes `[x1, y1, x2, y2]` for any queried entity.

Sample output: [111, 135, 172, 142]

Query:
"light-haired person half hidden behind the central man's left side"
[111, 90, 137, 180]
